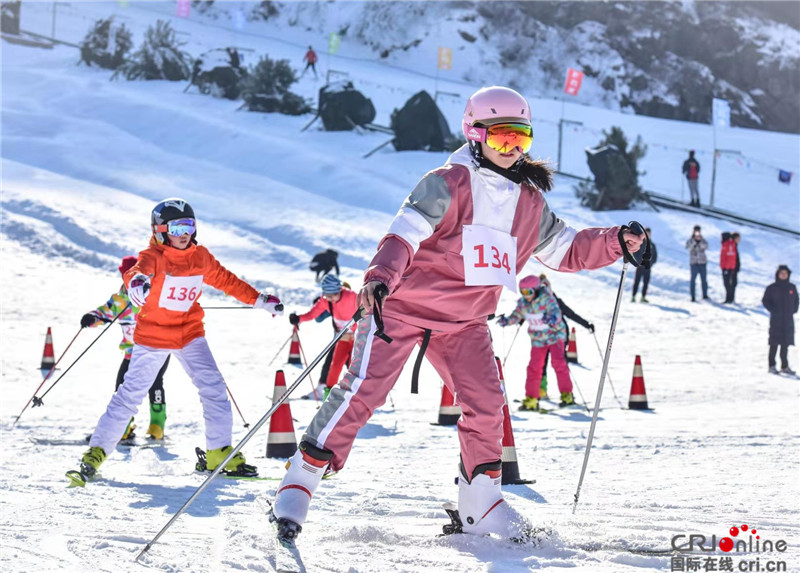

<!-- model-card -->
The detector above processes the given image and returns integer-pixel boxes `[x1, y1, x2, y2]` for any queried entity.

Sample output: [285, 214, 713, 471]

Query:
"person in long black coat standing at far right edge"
[761, 265, 800, 375]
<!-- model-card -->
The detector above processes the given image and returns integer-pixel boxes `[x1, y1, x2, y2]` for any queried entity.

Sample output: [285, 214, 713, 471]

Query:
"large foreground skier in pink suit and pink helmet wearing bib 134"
[271, 86, 642, 539]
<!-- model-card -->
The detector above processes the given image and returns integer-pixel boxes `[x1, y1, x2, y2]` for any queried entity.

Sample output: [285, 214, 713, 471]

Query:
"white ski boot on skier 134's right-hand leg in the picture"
[458, 461, 534, 542]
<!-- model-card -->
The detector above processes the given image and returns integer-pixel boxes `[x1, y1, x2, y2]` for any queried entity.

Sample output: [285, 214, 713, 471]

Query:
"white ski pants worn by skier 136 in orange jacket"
[89, 337, 233, 454]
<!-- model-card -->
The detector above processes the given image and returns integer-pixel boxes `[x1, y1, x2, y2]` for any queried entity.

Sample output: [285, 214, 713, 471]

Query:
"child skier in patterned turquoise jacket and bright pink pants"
[497, 275, 575, 411]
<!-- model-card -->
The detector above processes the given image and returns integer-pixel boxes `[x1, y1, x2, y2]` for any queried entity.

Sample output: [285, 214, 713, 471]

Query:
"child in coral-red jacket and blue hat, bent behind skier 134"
[289, 275, 358, 400]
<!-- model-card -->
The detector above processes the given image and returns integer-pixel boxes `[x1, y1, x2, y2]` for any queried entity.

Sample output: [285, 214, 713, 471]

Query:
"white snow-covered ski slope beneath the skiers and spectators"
[0, 8, 800, 572]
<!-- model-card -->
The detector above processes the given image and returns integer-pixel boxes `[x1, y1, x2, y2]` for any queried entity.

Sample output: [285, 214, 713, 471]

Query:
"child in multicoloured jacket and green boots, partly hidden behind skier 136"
[81, 257, 169, 440]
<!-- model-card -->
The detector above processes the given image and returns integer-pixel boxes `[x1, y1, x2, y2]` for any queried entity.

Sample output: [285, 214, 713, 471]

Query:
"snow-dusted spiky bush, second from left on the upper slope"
[113, 20, 193, 82]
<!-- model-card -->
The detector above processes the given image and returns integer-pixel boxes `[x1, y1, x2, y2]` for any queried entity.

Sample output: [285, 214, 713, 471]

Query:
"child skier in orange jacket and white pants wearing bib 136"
[67, 198, 283, 486]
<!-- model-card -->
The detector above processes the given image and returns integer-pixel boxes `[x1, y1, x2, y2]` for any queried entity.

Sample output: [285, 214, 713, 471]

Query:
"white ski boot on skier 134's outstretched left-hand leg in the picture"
[273, 441, 333, 525]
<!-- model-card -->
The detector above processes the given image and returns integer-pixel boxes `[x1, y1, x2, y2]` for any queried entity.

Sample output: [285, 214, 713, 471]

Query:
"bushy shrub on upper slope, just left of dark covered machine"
[241, 56, 311, 115]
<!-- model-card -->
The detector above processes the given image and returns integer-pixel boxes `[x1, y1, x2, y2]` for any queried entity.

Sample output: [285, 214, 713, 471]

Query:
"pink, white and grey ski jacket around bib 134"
[364, 145, 622, 331]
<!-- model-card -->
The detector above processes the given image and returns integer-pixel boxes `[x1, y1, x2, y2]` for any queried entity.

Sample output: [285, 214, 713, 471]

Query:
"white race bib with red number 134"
[461, 225, 517, 291]
